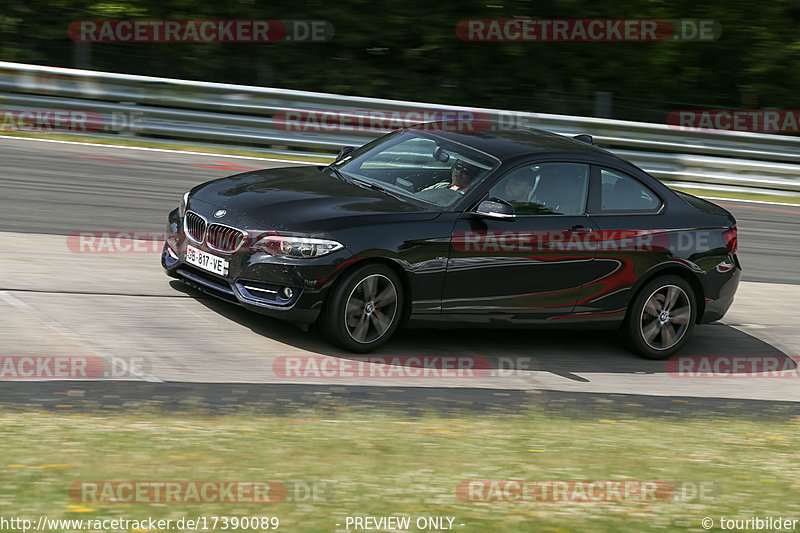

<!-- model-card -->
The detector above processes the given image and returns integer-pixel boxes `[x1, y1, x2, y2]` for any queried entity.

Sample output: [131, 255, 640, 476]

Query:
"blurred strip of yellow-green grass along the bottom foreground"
[0, 410, 800, 532]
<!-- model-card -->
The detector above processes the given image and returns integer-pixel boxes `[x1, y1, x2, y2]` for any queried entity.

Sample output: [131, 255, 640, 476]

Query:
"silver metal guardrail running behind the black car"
[0, 62, 800, 196]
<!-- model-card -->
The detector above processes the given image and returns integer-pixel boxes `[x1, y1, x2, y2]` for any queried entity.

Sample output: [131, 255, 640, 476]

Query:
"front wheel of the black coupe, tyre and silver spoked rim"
[320, 264, 403, 353]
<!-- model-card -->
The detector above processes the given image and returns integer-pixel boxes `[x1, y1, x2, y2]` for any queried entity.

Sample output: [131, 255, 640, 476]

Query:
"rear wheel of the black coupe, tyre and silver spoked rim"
[622, 275, 697, 360]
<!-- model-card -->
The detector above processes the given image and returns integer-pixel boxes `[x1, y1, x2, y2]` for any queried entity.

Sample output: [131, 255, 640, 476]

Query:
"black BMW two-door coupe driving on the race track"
[161, 122, 741, 359]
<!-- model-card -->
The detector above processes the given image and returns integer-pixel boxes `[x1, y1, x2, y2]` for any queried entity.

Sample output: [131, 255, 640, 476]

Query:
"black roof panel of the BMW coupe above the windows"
[409, 120, 619, 161]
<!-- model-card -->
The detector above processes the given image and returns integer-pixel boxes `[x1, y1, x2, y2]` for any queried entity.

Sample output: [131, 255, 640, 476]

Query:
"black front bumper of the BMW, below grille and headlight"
[161, 209, 348, 324]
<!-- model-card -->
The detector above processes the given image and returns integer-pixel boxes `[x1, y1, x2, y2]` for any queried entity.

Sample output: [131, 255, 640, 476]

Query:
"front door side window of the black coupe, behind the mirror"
[489, 163, 589, 215]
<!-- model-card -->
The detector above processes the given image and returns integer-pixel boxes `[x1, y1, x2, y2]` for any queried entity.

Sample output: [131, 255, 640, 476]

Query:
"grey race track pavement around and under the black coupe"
[0, 138, 800, 401]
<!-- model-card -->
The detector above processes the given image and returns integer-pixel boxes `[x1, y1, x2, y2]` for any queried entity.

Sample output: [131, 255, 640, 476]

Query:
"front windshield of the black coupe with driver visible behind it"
[335, 130, 499, 210]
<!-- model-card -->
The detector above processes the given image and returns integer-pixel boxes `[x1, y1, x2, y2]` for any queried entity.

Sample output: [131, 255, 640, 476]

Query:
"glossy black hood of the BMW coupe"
[189, 166, 439, 232]
